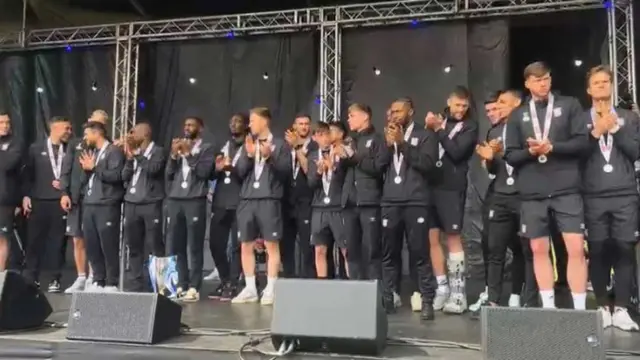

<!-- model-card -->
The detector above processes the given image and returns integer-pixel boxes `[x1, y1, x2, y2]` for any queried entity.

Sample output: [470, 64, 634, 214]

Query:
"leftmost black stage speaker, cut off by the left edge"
[0, 271, 53, 330]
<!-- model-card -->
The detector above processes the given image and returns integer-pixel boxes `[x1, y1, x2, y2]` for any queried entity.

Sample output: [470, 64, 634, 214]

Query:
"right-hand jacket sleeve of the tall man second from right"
[549, 98, 589, 156]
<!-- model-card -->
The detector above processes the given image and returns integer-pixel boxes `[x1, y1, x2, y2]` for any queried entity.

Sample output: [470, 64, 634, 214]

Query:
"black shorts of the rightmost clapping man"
[584, 196, 638, 242]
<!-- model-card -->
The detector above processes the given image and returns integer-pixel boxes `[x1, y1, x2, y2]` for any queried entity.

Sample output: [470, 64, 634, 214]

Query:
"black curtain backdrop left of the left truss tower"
[0, 47, 115, 143]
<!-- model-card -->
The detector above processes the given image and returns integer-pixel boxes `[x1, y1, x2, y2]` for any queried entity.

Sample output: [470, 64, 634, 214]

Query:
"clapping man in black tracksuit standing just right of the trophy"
[165, 117, 215, 302]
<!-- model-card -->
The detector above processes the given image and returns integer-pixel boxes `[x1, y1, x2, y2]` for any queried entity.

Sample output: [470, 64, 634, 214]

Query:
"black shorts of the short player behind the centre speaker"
[311, 209, 347, 248]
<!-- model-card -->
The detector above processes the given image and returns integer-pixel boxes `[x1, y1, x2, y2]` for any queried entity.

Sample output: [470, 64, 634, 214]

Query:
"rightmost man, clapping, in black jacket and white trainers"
[582, 66, 640, 331]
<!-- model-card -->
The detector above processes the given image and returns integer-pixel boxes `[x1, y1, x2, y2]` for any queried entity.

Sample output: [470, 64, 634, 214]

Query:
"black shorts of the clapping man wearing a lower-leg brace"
[429, 189, 467, 234]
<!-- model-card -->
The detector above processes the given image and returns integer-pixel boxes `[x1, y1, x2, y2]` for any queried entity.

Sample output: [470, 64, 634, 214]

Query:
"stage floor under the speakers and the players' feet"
[0, 282, 640, 360]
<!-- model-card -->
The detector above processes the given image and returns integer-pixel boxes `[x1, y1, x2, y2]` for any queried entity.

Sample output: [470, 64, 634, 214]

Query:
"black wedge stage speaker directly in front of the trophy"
[67, 292, 182, 344]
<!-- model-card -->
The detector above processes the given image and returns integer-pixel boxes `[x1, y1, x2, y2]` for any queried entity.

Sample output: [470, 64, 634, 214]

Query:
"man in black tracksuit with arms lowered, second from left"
[22, 117, 71, 293]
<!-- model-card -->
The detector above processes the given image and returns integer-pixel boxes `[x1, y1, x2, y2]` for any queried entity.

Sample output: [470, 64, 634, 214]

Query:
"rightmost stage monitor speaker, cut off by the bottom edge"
[481, 307, 605, 360]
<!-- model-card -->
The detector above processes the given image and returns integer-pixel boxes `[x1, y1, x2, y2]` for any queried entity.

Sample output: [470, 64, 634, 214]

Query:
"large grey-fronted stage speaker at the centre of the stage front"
[271, 279, 389, 355]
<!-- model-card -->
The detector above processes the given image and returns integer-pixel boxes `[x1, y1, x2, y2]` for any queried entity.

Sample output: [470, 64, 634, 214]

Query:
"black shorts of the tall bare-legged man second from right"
[520, 194, 584, 239]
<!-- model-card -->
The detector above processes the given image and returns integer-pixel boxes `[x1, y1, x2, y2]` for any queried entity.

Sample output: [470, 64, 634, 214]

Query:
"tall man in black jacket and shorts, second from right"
[504, 62, 589, 309]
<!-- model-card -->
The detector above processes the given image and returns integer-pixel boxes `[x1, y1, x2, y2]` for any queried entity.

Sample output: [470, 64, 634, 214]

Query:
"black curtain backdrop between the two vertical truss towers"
[137, 33, 319, 144]
